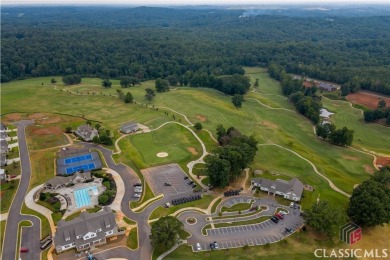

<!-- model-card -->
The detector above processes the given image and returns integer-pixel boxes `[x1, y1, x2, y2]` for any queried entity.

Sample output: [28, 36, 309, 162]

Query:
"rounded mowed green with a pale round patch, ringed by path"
[115, 123, 202, 169]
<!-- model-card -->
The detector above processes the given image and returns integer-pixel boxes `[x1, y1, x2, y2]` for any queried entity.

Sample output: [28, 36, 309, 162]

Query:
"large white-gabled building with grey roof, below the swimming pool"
[54, 207, 120, 253]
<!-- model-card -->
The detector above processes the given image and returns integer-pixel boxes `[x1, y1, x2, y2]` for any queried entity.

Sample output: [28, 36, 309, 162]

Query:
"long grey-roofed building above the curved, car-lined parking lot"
[251, 178, 303, 201]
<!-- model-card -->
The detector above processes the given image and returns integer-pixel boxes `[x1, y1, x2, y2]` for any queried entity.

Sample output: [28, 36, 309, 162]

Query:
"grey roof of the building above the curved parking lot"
[252, 178, 303, 197]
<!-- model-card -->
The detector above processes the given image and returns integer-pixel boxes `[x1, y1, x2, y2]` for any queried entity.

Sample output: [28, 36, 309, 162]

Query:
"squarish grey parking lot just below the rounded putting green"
[141, 164, 192, 197]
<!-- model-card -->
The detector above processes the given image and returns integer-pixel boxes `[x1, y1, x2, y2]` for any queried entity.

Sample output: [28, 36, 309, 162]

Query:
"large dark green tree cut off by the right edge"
[347, 179, 390, 227]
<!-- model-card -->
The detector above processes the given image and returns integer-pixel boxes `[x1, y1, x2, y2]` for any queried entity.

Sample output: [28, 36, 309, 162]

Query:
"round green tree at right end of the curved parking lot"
[305, 201, 347, 237]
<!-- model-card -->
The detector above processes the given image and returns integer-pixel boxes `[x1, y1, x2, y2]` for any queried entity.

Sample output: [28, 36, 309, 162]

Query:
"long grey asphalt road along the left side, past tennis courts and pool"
[2, 120, 41, 260]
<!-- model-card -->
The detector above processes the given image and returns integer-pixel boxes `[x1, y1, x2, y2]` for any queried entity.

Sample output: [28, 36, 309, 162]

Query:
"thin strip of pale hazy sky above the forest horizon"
[1, 0, 390, 6]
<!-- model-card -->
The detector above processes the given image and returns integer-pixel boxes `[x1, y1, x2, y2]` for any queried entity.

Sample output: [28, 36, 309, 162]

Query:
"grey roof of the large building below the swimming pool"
[54, 207, 116, 246]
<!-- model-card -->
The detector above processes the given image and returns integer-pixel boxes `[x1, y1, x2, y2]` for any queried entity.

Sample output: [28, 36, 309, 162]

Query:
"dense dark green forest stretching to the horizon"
[1, 7, 390, 94]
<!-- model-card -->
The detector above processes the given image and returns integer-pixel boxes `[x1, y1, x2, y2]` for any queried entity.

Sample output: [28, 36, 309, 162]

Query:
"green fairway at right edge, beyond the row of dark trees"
[322, 98, 390, 155]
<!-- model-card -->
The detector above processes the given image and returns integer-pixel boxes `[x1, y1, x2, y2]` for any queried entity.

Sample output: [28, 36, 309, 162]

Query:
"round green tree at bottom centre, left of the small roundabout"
[150, 216, 184, 252]
